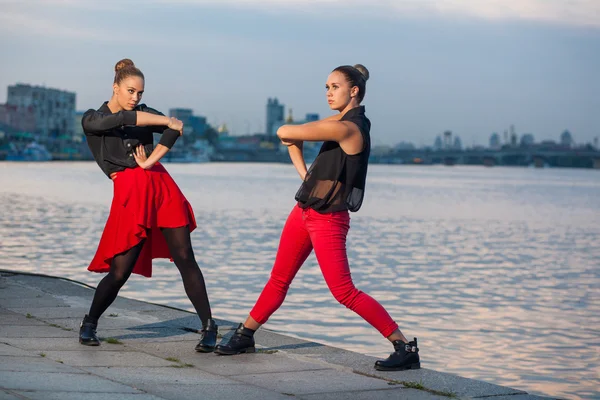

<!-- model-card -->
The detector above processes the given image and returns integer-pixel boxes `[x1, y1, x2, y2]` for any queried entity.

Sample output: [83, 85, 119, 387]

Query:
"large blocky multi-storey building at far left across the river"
[6, 83, 76, 139]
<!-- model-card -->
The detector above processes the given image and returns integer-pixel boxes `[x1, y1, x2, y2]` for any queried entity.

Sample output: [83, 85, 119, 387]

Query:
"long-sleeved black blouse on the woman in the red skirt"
[81, 102, 179, 178]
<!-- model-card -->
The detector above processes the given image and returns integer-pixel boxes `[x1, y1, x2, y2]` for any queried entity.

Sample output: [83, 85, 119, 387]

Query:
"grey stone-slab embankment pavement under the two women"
[0, 271, 542, 400]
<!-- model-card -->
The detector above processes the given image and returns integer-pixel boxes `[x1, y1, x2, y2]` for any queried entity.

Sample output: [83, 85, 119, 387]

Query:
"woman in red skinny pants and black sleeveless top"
[215, 65, 420, 371]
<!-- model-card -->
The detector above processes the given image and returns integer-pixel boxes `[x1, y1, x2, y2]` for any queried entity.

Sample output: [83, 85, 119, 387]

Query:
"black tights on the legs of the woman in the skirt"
[89, 226, 212, 324]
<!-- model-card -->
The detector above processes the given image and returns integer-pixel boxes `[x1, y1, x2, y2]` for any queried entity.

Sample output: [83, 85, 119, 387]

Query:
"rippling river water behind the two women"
[0, 163, 600, 398]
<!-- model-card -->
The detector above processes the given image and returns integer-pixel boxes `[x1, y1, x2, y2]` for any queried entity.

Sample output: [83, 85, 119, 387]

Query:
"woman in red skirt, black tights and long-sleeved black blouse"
[79, 59, 217, 352]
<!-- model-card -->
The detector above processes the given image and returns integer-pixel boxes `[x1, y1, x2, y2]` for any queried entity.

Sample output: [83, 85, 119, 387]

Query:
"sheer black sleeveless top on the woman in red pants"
[296, 106, 371, 213]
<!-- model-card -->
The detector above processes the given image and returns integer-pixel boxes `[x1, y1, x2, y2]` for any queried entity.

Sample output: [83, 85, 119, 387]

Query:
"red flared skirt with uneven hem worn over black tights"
[88, 163, 196, 278]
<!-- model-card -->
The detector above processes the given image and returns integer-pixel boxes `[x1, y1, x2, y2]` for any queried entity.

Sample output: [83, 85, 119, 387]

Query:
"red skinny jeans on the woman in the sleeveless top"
[250, 206, 398, 337]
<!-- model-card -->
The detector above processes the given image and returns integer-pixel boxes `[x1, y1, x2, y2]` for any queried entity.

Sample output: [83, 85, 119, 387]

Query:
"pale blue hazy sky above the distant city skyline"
[0, 0, 600, 146]
